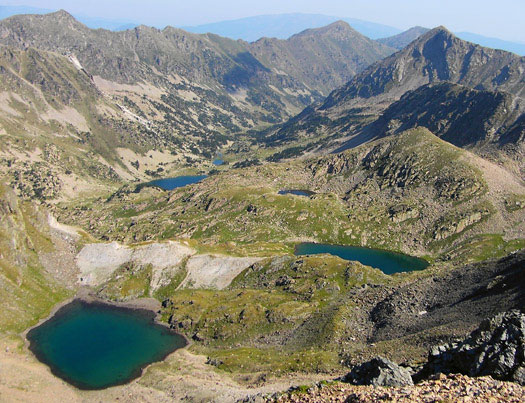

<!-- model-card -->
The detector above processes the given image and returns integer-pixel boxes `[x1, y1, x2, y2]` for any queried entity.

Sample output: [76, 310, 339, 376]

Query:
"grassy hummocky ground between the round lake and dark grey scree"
[162, 256, 391, 373]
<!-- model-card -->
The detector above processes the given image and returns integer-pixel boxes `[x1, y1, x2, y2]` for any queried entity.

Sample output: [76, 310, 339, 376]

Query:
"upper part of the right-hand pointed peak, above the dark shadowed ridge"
[322, 27, 525, 109]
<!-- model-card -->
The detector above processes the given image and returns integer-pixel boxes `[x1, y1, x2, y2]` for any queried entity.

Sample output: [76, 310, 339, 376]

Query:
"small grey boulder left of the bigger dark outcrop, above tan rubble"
[343, 357, 414, 386]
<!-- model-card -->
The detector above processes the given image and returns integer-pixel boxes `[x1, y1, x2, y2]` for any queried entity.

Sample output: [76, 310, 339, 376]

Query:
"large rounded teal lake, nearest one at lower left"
[27, 300, 186, 389]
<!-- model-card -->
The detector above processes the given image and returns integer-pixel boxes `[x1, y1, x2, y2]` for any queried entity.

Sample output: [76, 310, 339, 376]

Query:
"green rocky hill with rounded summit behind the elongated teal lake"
[56, 129, 525, 262]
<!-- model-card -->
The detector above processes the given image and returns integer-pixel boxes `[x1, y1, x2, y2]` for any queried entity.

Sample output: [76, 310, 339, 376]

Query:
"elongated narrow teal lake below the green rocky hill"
[295, 243, 429, 274]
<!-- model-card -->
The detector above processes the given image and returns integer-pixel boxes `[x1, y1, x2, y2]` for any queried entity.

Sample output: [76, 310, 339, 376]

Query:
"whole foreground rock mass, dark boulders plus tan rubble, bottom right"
[274, 310, 525, 402]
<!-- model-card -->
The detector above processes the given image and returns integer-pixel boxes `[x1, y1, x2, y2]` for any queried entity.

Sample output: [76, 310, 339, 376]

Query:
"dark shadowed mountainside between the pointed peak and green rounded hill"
[369, 82, 524, 147]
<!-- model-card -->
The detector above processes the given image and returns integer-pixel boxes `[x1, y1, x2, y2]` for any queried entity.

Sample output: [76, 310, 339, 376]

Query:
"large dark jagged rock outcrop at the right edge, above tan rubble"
[418, 310, 525, 385]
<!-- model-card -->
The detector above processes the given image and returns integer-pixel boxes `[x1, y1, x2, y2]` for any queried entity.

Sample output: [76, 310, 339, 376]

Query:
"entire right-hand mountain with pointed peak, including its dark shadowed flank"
[262, 27, 525, 177]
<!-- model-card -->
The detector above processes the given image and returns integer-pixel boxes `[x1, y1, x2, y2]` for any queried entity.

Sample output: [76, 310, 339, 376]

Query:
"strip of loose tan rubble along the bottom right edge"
[272, 375, 525, 403]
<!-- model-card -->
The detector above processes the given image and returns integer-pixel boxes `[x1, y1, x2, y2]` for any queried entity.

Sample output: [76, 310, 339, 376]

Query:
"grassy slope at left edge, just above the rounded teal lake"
[0, 183, 71, 335]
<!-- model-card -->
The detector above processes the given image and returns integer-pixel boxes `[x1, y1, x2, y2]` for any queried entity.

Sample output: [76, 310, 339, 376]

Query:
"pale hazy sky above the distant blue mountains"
[0, 0, 525, 42]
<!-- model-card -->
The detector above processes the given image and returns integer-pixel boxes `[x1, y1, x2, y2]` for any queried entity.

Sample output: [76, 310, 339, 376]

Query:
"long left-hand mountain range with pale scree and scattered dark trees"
[0, 11, 393, 199]
